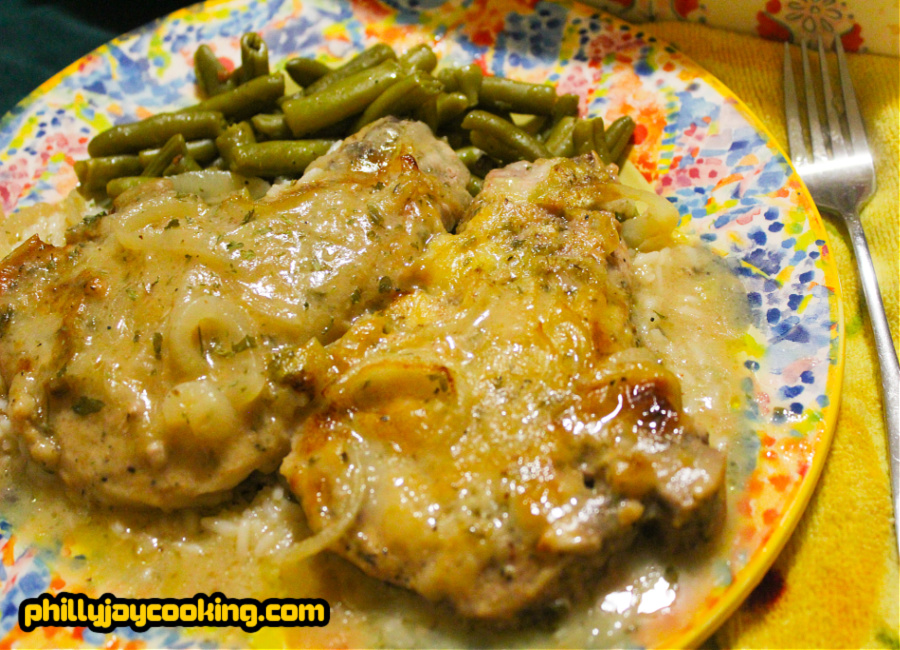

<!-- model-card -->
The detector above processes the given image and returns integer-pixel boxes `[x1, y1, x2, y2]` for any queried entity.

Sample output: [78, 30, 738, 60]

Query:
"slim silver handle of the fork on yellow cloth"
[843, 206, 900, 554]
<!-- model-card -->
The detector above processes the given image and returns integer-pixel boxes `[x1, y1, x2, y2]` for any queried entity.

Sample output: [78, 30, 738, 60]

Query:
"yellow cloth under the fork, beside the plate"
[644, 22, 900, 648]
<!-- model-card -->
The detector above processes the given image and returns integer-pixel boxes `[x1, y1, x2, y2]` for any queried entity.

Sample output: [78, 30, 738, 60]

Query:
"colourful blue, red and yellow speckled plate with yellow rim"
[0, 0, 843, 647]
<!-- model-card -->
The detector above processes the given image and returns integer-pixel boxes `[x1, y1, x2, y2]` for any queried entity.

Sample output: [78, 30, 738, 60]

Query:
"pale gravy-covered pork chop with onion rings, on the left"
[0, 119, 469, 509]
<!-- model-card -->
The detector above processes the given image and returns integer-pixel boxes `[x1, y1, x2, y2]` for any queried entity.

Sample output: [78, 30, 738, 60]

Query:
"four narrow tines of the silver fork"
[784, 36, 868, 166]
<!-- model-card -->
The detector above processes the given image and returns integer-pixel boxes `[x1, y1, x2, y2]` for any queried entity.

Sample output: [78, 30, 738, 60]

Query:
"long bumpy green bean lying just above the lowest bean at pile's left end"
[88, 110, 225, 158]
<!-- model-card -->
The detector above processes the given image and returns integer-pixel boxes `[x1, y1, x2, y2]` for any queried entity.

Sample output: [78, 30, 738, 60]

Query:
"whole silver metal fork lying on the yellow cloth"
[784, 37, 900, 553]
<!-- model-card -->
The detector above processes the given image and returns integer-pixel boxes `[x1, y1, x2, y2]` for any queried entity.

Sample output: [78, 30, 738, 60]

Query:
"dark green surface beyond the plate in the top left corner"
[0, 0, 194, 115]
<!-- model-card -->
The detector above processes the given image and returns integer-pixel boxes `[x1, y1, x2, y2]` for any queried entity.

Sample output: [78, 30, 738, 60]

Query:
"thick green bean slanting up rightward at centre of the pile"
[281, 61, 403, 137]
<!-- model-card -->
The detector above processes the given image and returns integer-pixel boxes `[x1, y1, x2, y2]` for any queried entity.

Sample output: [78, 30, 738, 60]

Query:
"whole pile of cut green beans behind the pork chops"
[75, 32, 635, 198]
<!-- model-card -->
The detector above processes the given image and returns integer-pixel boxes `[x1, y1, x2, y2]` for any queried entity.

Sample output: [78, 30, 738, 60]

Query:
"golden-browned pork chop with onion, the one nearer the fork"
[282, 157, 724, 620]
